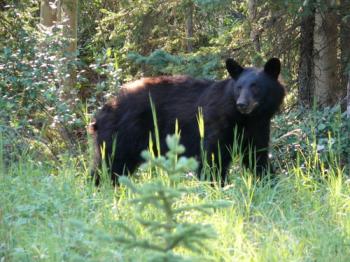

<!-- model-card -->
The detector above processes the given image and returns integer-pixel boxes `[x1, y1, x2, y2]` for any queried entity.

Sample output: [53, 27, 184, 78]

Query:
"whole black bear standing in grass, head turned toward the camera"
[90, 58, 285, 185]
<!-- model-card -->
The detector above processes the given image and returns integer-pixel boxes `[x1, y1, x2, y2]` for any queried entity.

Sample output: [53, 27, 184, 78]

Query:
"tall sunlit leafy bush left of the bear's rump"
[0, 3, 84, 164]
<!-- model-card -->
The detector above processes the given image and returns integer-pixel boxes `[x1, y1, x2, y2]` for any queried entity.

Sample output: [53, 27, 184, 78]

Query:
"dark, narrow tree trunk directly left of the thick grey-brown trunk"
[298, 6, 315, 107]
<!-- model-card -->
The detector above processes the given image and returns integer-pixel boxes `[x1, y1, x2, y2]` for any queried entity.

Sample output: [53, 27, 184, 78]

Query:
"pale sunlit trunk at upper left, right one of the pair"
[58, 0, 78, 107]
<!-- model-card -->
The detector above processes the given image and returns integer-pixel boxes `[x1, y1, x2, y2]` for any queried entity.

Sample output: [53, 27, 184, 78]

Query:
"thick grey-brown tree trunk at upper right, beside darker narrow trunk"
[314, 0, 338, 106]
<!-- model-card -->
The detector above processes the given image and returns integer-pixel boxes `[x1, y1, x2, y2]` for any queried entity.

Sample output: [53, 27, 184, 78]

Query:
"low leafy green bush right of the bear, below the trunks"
[272, 106, 350, 176]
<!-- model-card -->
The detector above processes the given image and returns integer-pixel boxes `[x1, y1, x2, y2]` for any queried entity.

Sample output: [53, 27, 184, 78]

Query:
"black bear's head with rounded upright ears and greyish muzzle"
[226, 58, 285, 115]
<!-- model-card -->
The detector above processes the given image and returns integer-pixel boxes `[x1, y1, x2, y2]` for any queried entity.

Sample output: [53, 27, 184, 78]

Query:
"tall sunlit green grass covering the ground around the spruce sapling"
[0, 108, 350, 261]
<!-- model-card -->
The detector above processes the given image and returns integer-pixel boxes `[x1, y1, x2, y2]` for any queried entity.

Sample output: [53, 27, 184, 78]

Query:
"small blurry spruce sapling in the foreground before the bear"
[118, 134, 225, 261]
